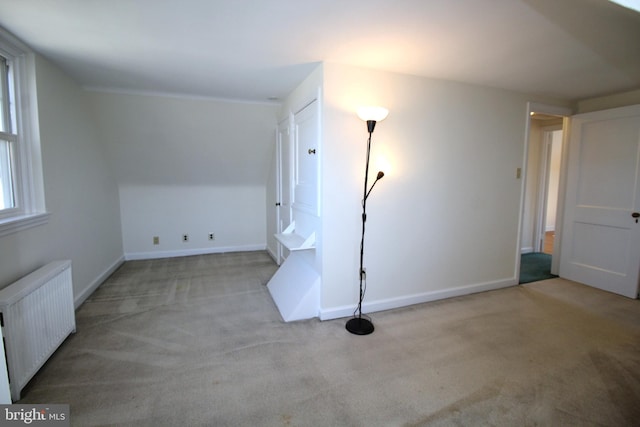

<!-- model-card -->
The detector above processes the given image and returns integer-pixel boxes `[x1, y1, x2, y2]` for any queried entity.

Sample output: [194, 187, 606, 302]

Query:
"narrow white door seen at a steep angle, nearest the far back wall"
[276, 119, 293, 265]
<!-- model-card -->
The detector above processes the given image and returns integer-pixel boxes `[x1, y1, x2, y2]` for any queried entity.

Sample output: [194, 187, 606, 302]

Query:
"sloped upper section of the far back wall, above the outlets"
[85, 92, 277, 186]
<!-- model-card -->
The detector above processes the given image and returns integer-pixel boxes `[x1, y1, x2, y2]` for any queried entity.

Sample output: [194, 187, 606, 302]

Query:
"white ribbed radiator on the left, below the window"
[0, 260, 76, 402]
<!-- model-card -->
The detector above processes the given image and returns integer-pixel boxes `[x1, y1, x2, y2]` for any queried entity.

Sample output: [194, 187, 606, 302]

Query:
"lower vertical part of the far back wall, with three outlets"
[120, 185, 266, 259]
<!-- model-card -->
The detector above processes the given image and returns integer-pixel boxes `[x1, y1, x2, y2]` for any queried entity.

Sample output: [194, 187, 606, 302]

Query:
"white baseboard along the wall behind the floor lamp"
[320, 278, 518, 320]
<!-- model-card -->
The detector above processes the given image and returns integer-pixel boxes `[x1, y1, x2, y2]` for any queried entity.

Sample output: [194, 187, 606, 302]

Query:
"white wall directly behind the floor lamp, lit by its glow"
[321, 64, 552, 318]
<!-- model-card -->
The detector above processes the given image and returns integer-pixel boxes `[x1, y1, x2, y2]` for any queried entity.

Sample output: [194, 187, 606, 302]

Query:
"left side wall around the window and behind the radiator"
[0, 56, 122, 305]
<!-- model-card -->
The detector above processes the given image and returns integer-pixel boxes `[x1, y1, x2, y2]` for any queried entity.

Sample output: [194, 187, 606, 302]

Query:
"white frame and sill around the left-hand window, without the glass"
[0, 28, 49, 237]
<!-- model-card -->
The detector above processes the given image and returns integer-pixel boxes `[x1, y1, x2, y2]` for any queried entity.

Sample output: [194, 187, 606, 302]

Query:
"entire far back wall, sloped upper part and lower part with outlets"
[90, 92, 279, 259]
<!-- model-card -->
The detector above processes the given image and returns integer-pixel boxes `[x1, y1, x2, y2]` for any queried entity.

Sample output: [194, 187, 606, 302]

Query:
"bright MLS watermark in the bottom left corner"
[0, 405, 71, 427]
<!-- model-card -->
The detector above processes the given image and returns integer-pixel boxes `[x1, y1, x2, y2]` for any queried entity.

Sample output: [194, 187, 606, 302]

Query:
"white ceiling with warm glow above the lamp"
[0, 0, 640, 101]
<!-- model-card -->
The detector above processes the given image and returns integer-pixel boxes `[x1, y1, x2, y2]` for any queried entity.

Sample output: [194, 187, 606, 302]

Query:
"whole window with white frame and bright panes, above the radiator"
[0, 28, 48, 236]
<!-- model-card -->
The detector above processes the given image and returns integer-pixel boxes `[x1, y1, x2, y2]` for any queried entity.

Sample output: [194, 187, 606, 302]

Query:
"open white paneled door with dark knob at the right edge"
[560, 105, 640, 298]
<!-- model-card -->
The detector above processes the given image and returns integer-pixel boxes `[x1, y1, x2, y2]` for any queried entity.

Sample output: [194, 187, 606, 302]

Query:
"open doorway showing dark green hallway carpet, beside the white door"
[517, 104, 570, 283]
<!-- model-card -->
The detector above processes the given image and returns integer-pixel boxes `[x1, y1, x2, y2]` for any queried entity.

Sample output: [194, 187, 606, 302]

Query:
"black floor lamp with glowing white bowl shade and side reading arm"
[346, 107, 389, 335]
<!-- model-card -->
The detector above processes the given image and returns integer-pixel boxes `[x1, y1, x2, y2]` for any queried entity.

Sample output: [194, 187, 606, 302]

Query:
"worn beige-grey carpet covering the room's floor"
[21, 252, 640, 427]
